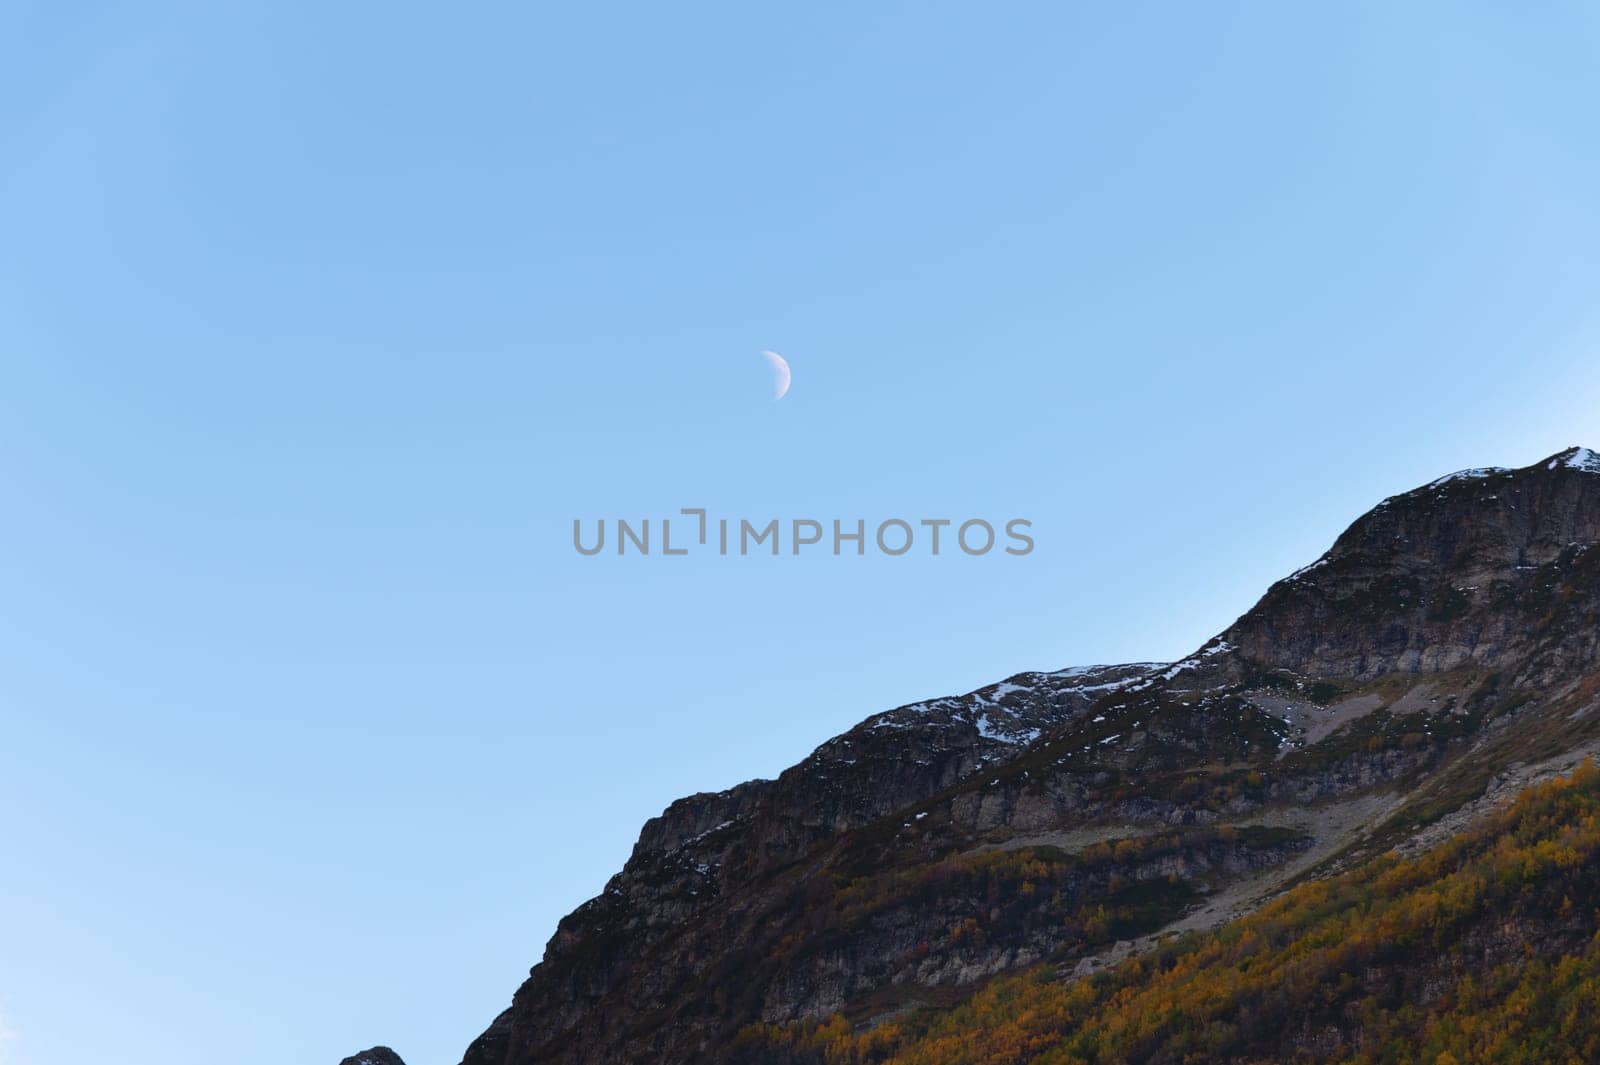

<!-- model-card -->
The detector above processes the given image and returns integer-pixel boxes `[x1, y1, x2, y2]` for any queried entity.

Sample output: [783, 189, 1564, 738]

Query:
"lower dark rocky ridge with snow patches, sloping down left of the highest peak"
[467, 664, 1150, 1062]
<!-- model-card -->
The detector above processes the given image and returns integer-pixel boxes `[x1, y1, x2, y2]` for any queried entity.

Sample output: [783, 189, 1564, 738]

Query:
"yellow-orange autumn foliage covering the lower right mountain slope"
[744, 761, 1600, 1065]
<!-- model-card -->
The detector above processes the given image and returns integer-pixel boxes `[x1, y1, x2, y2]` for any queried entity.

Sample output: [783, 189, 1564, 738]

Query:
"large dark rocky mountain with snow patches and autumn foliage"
[464, 448, 1600, 1065]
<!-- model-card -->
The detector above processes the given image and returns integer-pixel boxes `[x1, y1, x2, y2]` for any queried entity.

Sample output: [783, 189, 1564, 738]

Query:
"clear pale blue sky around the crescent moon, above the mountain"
[9, 0, 1600, 1065]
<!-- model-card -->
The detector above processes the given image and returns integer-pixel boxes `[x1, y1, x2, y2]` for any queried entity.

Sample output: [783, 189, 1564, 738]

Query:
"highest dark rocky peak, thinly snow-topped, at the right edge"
[1224, 448, 1600, 678]
